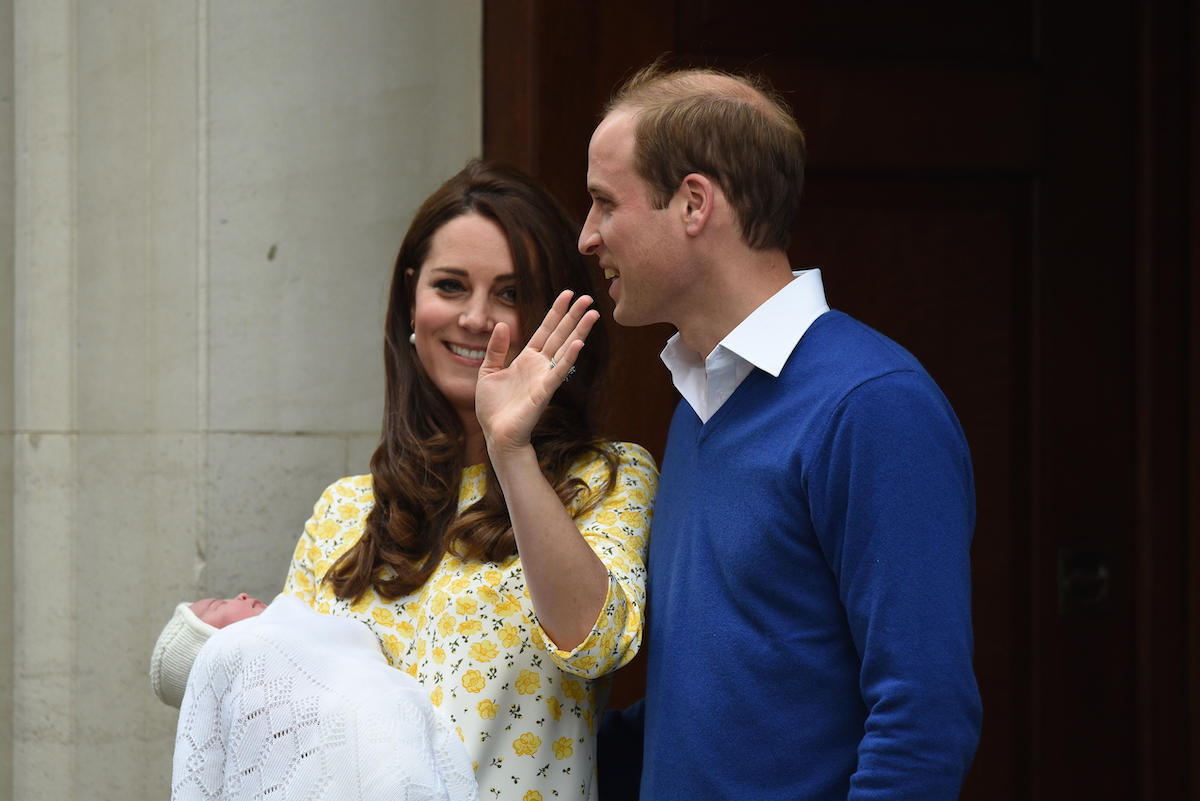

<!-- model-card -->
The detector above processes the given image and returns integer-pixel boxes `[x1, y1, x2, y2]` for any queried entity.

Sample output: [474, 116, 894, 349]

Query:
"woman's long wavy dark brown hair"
[325, 159, 617, 600]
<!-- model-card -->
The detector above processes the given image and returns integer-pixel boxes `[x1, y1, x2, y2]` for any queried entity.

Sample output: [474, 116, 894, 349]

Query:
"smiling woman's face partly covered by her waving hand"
[412, 212, 524, 426]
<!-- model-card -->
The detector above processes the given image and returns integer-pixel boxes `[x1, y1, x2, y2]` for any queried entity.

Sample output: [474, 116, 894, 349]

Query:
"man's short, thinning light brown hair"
[606, 60, 804, 251]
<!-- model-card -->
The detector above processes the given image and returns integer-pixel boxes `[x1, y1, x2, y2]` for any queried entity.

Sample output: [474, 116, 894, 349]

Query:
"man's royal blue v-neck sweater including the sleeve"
[642, 312, 980, 801]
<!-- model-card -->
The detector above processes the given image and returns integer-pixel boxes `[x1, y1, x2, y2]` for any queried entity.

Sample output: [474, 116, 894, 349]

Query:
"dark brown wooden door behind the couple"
[485, 0, 1200, 801]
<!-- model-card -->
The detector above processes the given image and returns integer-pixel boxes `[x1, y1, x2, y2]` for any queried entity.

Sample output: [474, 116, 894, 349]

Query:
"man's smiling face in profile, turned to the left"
[580, 109, 684, 325]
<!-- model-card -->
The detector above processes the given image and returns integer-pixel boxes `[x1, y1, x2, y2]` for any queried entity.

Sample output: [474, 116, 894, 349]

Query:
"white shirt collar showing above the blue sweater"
[661, 270, 829, 423]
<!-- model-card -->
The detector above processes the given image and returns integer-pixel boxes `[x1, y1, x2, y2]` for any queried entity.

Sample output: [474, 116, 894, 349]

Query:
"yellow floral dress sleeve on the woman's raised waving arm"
[538, 442, 659, 679]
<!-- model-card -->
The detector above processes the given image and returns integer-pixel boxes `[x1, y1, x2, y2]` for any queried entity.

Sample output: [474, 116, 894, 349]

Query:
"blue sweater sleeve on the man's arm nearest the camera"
[812, 372, 980, 801]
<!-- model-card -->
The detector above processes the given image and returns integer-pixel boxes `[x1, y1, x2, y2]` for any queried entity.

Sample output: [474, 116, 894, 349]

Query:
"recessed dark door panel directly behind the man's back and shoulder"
[791, 170, 1033, 797]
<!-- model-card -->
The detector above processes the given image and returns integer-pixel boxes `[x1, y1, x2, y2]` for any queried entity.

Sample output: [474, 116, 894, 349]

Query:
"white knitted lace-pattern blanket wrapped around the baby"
[170, 595, 479, 801]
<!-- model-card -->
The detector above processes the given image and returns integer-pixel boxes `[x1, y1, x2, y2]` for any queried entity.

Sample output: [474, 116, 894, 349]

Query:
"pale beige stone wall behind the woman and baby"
[0, 0, 481, 801]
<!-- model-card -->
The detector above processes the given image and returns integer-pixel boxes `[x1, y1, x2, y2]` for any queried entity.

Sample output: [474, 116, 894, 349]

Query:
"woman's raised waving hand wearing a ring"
[475, 290, 600, 462]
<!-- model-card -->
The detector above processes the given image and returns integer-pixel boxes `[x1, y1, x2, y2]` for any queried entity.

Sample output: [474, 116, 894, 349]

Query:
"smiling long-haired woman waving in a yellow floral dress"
[284, 162, 658, 801]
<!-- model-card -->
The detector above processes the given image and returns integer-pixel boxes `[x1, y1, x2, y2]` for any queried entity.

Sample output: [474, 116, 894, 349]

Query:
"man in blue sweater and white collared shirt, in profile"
[580, 66, 980, 801]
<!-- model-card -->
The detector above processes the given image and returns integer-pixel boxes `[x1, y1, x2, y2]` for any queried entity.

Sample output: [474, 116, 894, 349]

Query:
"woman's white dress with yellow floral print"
[283, 442, 658, 801]
